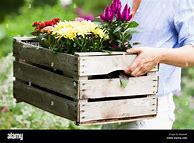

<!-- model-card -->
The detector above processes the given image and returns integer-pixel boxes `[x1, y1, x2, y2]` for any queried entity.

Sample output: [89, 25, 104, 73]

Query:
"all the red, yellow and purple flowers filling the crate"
[32, 0, 138, 54]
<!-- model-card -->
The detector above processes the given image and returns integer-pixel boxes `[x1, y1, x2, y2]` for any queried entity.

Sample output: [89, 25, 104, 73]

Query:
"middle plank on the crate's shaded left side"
[14, 61, 78, 98]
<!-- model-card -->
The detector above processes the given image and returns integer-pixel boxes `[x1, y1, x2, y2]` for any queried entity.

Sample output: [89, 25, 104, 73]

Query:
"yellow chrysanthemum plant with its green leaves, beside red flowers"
[50, 20, 108, 54]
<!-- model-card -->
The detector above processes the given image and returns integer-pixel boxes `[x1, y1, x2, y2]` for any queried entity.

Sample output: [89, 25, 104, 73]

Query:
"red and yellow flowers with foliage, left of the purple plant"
[32, 18, 108, 54]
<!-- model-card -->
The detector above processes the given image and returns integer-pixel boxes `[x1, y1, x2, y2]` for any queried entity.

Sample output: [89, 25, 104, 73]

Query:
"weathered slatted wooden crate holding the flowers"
[13, 37, 158, 124]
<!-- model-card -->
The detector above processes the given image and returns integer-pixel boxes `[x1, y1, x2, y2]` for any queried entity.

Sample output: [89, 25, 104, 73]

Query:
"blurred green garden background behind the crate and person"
[0, 0, 194, 129]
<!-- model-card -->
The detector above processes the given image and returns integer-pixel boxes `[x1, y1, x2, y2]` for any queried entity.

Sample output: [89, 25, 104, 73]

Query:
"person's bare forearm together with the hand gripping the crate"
[125, 45, 194, 76]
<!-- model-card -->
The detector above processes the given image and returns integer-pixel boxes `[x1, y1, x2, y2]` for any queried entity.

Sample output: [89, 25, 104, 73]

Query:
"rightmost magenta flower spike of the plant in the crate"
[117, 4, 132, 21]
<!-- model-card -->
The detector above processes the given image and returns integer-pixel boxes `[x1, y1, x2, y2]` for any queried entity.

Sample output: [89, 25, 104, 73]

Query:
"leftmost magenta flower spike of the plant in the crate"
[100, 6, 114, 22]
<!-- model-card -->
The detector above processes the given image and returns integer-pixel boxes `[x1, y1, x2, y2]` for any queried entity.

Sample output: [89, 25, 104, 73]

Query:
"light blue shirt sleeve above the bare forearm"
[174, 0, 194, 46]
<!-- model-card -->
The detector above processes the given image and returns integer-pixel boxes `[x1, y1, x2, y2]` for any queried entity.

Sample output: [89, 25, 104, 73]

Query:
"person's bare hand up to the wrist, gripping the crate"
[125, 47, 163, 76]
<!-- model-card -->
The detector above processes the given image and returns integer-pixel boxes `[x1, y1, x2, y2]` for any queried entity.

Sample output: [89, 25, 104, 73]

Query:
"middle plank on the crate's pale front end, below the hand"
[79, 72, 158, 99]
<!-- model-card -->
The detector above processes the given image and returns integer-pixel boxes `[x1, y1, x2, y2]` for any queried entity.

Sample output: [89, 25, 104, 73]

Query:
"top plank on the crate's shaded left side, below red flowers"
[13, 40, 78, 77]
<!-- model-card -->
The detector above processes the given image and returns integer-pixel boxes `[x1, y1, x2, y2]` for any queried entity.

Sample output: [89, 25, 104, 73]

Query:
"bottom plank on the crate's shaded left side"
[14, 81, 77, 121]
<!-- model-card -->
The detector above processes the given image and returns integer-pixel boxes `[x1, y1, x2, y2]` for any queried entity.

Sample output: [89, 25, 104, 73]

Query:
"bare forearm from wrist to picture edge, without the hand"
[160, 45, 194, 68]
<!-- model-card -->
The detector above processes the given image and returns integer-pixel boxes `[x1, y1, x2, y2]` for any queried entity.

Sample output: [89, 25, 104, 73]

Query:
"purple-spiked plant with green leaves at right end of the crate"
[100, 0, 138, 51]
